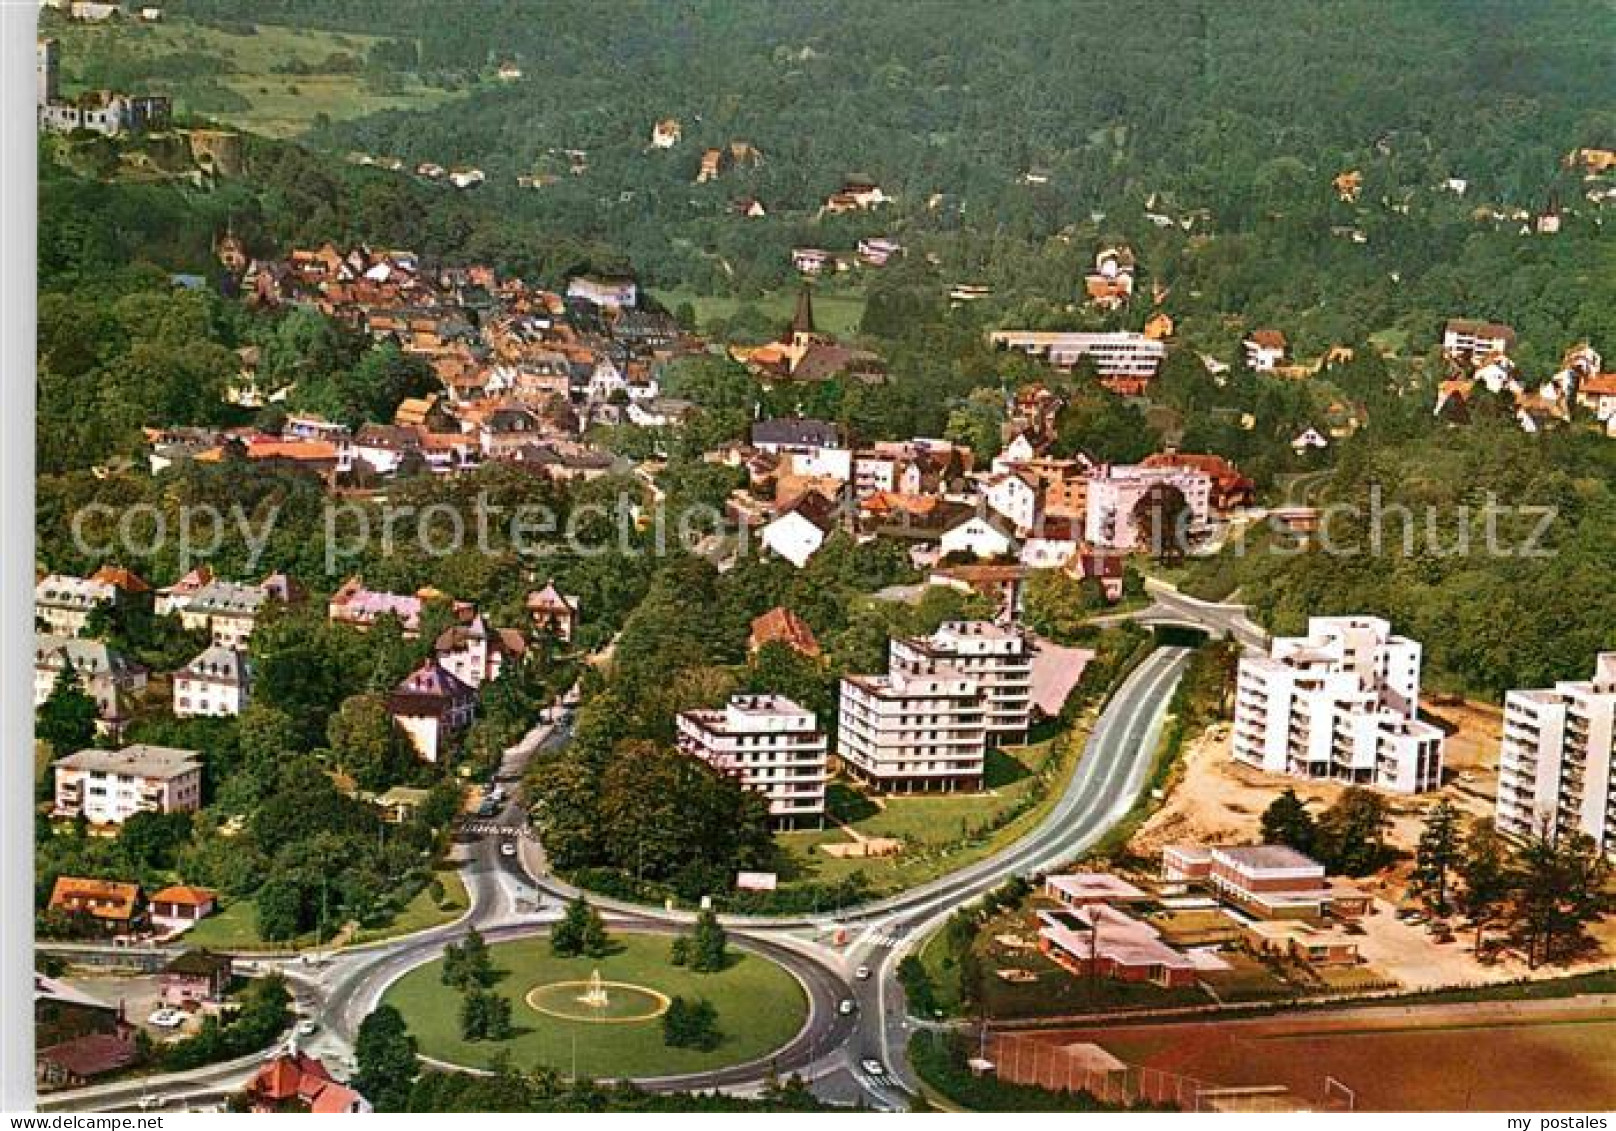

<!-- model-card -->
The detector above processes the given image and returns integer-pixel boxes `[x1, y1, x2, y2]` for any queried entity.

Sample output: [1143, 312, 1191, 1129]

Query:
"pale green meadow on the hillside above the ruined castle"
[48, 18, 452, 137]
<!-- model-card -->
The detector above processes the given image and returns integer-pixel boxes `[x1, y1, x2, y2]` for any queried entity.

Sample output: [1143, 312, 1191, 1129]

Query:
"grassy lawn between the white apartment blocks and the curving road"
[776, 729, 1088, 895]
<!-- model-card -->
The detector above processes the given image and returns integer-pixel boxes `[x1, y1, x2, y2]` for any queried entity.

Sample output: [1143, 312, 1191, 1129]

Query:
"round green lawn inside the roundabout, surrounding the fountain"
[383, 934, 808, 1078]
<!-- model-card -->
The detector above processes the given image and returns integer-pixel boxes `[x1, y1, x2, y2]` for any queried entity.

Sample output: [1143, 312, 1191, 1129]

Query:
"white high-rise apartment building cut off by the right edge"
[1496, 651, 1616, 853]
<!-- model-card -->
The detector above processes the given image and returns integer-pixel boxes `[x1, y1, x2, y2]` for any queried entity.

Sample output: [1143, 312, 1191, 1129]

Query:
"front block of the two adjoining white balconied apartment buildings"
[837, 672, 987, 793]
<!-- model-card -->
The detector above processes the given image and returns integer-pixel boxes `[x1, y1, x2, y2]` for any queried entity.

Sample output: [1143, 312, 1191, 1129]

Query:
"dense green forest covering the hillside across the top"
[160, 0, 1616, 368]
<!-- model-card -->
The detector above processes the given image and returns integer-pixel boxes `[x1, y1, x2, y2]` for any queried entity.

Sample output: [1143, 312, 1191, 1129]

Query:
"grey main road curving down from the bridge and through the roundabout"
[42, 648, 1189, 1110]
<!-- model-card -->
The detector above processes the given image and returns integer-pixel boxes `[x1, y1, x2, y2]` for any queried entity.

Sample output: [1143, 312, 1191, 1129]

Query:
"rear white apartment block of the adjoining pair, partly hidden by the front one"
[890, 620, 1033, 743]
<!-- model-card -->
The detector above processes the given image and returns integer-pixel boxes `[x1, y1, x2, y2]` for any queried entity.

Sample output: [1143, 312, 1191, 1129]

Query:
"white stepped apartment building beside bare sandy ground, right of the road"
[1233, 617, 1443, 793]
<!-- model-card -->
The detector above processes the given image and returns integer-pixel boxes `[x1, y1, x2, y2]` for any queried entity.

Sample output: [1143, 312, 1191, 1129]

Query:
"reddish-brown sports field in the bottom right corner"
[1014, 999, 1616, 1112]
